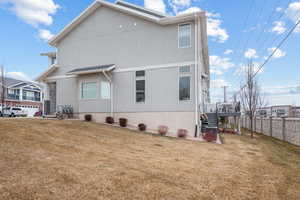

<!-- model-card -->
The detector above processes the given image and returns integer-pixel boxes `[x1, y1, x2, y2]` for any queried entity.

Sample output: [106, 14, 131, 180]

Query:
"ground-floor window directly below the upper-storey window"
[179, 66, 191, 101]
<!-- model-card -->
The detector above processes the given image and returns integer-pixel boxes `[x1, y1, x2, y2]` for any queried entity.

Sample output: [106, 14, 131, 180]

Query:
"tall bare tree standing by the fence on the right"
[240, 61, 266, 138]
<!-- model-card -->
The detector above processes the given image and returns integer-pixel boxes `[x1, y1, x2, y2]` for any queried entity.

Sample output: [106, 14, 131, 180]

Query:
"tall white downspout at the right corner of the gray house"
[194, 14, 199, 137]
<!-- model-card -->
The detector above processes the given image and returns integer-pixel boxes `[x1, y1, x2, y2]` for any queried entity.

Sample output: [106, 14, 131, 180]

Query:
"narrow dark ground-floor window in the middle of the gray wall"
[135, 71, 145, 103]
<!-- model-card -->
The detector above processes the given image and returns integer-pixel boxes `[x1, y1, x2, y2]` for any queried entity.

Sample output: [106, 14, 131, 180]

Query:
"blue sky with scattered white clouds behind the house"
[0, 0, 300, 105]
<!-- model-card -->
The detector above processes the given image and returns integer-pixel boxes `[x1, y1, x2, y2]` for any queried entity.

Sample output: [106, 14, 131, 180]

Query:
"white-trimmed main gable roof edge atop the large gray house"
[49, 0, 205, 46]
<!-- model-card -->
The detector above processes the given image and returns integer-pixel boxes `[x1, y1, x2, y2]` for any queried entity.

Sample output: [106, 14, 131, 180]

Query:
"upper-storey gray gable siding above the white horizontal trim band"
[53, 7, 195, 75]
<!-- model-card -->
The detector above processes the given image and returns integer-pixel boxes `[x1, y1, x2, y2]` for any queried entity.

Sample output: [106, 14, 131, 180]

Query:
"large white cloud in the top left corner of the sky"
[0, 0, 59, 27]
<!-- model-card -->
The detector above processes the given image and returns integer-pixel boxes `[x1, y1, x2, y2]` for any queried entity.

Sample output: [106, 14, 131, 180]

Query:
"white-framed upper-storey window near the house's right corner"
[178, 24, 191, 48]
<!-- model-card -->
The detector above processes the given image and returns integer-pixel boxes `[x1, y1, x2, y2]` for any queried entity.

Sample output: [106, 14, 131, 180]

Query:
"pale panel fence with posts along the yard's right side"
[241, 117, 300, 146]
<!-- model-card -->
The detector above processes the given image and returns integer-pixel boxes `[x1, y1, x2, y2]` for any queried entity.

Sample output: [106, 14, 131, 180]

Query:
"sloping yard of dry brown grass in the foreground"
[0, 119, 300, 200]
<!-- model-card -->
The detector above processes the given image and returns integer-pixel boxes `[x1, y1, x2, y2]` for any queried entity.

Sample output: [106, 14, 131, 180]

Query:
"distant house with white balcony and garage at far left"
[0, 77, 43, 116]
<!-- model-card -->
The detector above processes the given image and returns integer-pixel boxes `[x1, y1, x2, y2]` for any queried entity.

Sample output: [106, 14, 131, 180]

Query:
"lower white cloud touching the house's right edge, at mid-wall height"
[209, 55, 234, 75]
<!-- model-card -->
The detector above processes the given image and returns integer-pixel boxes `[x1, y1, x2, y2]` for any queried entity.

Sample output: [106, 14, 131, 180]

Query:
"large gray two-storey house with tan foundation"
[37, 1, 210, 136]
